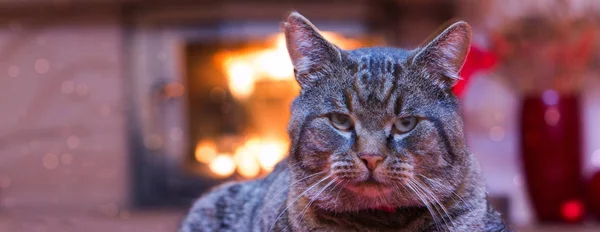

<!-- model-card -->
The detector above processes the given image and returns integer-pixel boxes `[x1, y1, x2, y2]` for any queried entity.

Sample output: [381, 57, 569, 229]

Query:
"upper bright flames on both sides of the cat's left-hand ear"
[223, 32, 360, 99]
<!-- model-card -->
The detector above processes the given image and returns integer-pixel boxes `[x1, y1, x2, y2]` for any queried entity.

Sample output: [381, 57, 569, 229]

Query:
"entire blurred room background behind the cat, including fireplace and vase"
[0, 0, 600, 232]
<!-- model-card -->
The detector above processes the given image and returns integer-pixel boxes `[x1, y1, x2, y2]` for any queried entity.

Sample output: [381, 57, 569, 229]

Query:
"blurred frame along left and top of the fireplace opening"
[122, 1, 371, 208]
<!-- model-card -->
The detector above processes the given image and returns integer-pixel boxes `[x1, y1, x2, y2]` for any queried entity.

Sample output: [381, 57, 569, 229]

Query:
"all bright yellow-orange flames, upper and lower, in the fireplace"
[195, 32, 361, 179]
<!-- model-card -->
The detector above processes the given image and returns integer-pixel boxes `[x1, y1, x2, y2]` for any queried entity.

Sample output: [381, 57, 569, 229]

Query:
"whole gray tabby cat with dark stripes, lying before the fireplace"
[180, 13, 508, 232]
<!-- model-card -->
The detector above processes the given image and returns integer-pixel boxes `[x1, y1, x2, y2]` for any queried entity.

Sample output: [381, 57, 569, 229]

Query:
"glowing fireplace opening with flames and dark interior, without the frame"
[185, 31, 376, 181]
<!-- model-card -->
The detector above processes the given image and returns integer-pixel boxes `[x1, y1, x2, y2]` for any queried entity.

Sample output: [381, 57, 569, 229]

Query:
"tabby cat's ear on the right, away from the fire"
[412, 21, 471, 89]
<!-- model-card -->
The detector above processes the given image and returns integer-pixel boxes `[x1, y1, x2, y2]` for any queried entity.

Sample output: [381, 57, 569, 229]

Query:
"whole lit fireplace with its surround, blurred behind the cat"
[124, 1, 458, 206]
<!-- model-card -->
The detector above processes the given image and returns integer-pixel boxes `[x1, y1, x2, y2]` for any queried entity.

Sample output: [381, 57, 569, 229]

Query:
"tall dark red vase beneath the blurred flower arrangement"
[520, 90, 585, 223]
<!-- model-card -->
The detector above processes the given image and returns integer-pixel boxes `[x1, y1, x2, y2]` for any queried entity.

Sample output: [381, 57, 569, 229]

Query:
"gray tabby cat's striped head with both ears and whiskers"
[284, 13, 471, 211]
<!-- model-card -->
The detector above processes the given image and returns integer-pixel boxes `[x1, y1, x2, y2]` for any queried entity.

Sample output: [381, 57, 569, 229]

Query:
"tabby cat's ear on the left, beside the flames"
[283, 12, 341, 88]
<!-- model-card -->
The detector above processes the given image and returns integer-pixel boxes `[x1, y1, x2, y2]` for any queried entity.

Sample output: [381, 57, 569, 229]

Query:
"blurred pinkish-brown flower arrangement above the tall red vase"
[488, 0, 600, 94]
